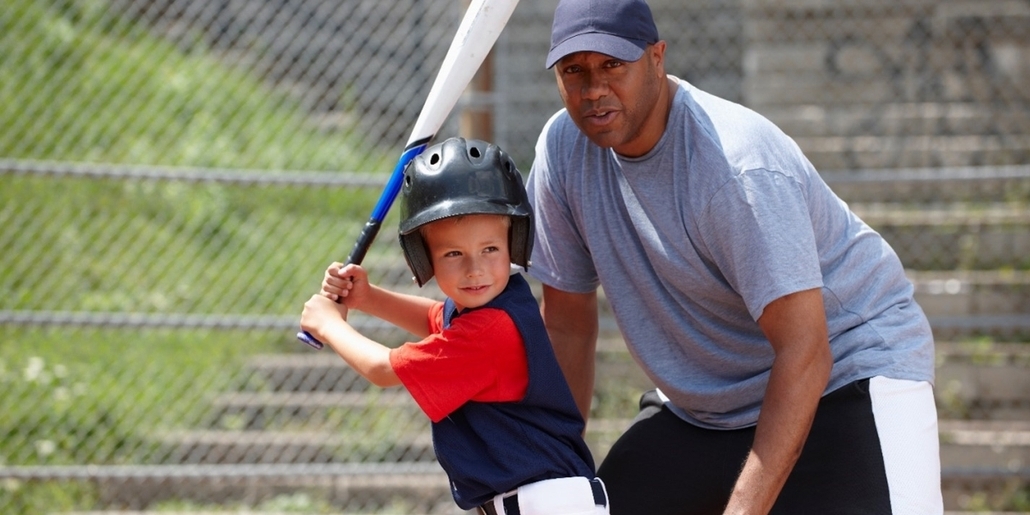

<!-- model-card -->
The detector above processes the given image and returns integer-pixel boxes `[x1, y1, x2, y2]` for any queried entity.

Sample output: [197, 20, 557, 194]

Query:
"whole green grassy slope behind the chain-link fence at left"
[0, 0, 414, 514]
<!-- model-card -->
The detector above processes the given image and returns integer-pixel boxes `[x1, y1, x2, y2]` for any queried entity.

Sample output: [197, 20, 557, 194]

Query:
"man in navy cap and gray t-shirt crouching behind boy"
[527, 0, 942, 515]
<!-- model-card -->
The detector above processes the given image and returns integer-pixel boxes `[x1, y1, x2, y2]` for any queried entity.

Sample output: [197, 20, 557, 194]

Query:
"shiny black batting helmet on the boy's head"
[400, 138, 533, 286]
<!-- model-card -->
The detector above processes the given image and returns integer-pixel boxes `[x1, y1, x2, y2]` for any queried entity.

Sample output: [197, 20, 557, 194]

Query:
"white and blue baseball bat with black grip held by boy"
[297, 0, 518, 349]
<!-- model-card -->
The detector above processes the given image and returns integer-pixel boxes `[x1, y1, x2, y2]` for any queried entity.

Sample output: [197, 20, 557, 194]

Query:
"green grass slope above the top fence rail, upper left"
[0, 0, 384, 170]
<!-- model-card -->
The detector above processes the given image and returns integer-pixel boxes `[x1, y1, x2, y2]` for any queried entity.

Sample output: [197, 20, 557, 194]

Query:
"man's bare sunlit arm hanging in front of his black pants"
[725, 288, 833, 515]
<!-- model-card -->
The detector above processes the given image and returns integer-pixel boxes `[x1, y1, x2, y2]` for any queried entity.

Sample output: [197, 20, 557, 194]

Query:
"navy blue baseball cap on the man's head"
[547, 0, 658, 68]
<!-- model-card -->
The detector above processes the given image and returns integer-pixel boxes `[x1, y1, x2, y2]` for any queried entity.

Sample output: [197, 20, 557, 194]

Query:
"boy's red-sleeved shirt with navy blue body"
[390, 274, 594, 510]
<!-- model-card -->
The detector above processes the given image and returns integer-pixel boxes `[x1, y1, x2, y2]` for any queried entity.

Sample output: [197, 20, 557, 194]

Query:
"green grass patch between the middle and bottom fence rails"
[0, 328, 283, 467]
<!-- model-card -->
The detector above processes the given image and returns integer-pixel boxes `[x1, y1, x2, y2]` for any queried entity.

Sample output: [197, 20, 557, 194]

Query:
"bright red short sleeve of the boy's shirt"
[389, 303, 529, 422]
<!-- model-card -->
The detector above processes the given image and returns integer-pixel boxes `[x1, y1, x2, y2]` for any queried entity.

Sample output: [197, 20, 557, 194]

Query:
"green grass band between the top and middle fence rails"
[0, 175, 394, 314]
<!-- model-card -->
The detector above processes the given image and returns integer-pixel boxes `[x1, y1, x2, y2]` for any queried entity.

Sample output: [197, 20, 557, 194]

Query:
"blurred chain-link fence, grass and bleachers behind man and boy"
[0, 0, 1030, 515]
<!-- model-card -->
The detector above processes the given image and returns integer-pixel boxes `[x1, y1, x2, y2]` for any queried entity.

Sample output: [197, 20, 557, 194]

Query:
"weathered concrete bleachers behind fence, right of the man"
[742, 8, 1030, 511]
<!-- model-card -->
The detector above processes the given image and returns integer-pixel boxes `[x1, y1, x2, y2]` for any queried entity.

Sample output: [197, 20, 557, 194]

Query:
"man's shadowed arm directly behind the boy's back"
[541, 285, 597, 420]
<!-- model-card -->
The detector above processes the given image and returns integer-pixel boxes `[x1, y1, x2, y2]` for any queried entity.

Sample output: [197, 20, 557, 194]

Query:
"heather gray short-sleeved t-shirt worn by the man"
[527, 77, 933, 428]
